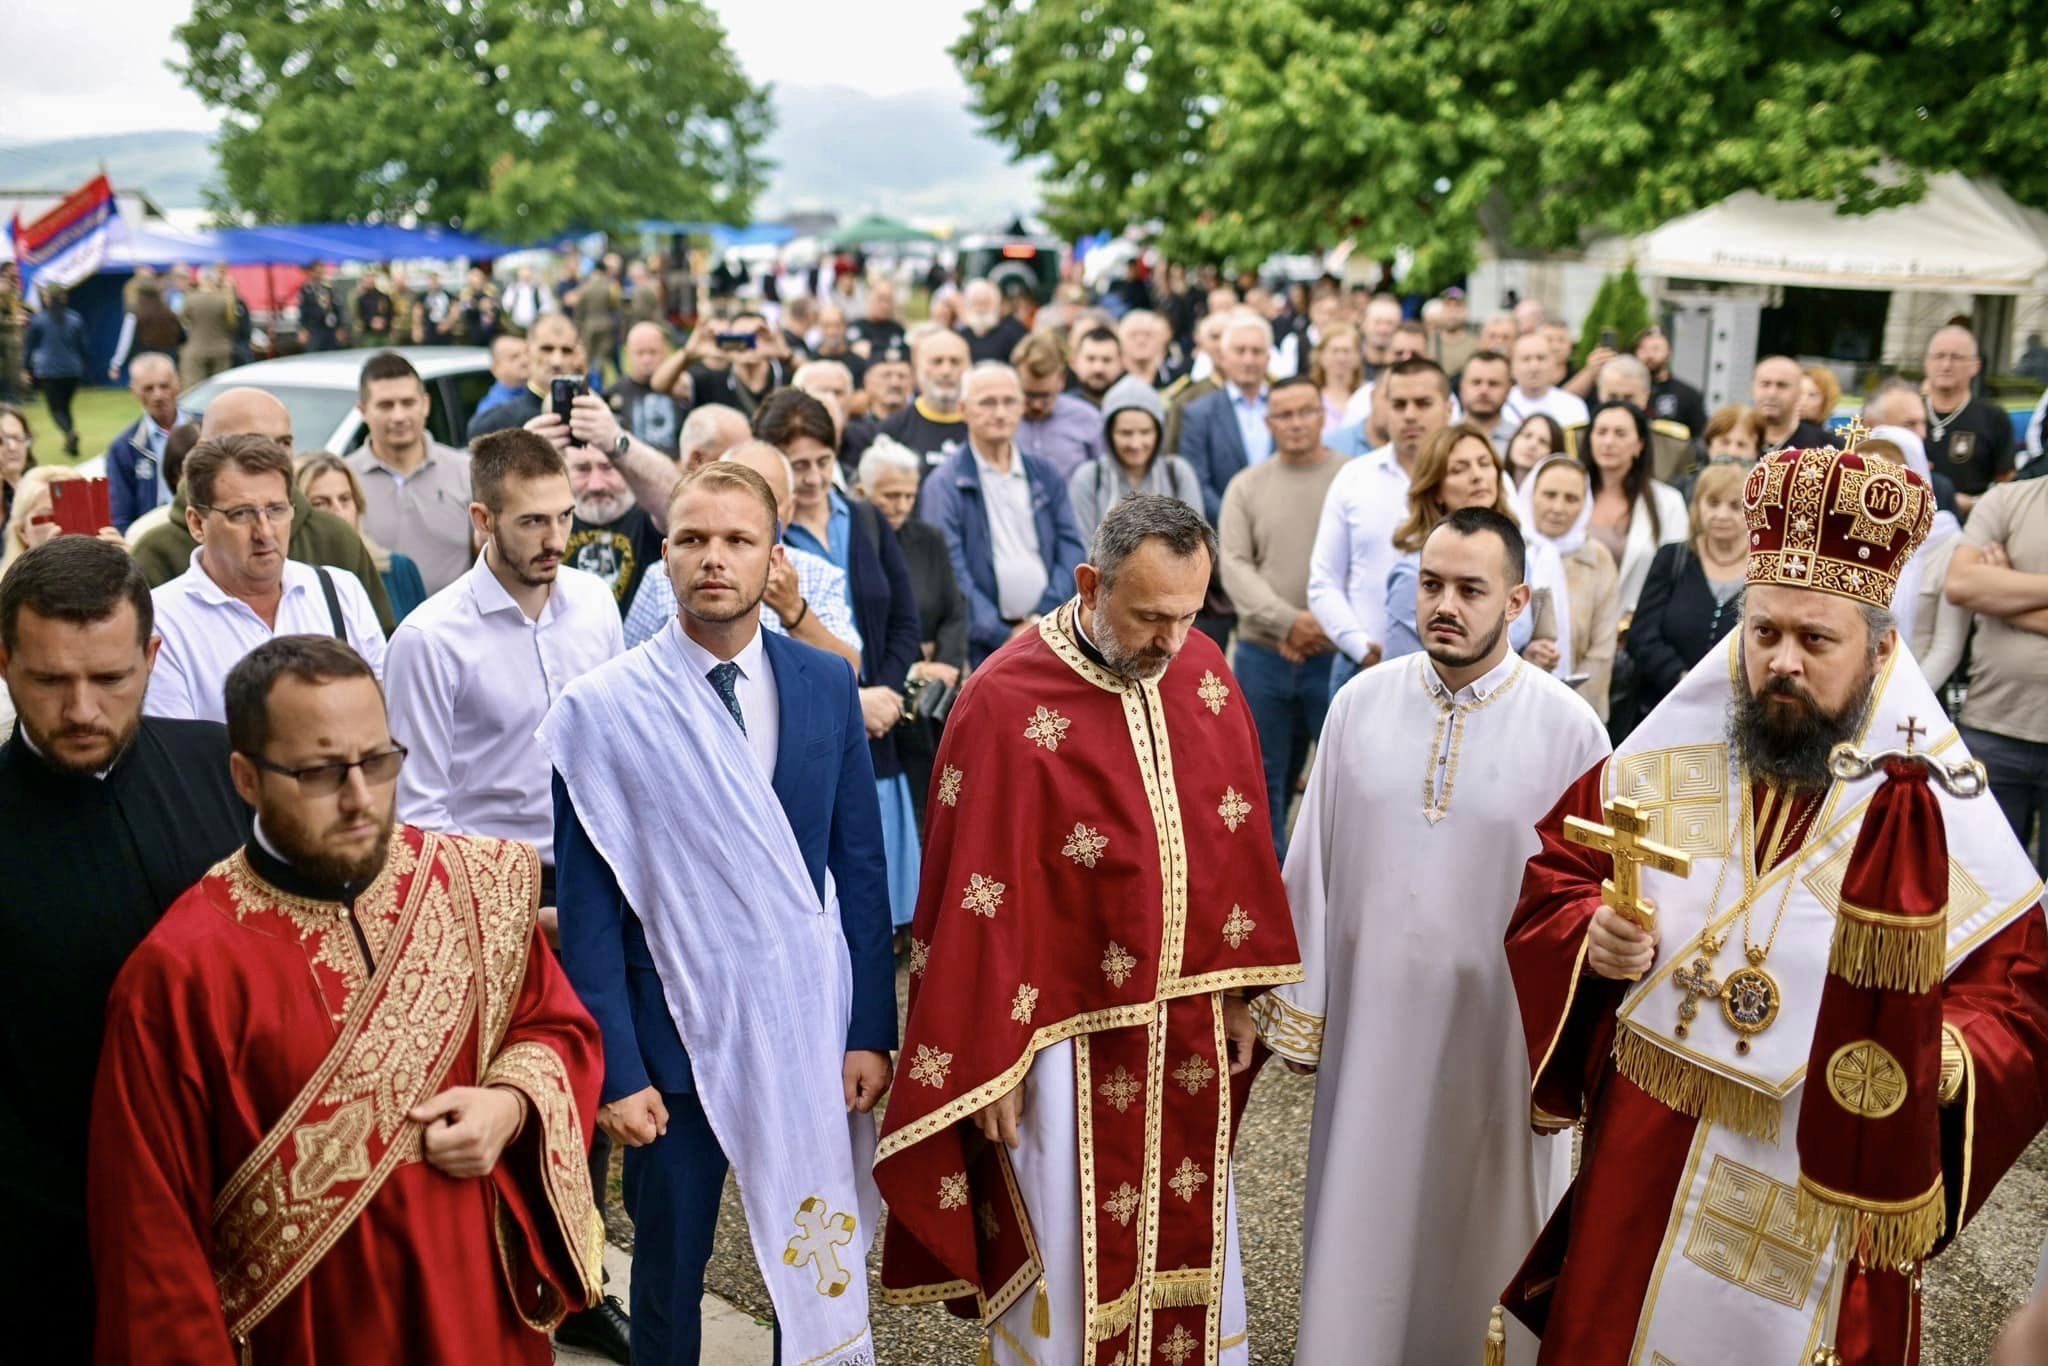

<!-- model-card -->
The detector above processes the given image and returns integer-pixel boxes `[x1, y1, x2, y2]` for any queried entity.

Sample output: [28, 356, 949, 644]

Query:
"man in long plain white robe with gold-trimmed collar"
[1253, 508, 1608, 1366]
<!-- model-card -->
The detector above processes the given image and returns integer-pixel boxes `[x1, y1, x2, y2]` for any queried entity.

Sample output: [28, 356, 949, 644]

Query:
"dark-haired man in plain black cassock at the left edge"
[0, 537, 250, 1362]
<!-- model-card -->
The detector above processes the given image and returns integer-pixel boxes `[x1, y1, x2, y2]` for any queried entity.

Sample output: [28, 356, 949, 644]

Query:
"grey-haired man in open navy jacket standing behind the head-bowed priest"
[918, 360, 1087, 664]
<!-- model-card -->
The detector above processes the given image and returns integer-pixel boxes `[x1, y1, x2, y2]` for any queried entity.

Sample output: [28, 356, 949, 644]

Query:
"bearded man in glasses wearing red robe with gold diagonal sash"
[88, 637, 602, 1366]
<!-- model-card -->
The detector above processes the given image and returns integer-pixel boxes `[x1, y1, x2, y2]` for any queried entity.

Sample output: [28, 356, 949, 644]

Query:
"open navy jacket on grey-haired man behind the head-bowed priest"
[918, 446, 1087, 664]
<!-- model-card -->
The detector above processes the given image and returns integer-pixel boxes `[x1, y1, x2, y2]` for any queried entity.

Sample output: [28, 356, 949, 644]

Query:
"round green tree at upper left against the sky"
[178, 0, 772, 242]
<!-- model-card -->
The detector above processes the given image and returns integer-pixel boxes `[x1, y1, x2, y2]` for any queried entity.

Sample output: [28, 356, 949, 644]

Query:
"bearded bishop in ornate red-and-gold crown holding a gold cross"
[1499, 442, 2048, 1366]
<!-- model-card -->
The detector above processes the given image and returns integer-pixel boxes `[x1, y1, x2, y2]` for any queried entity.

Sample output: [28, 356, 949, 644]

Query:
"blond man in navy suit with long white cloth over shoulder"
[541, 462, 897, 1366]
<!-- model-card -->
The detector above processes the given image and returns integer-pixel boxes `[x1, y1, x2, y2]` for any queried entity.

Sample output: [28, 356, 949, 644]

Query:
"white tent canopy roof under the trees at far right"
[1587, 174, 2048, 295]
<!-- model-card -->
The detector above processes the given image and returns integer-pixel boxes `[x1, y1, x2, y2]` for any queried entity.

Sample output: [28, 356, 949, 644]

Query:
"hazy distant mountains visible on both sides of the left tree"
[0, 86, 1038, 225]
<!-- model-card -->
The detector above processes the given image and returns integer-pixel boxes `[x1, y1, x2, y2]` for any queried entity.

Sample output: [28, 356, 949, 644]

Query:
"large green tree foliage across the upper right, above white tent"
[952, 0, 2048, 283]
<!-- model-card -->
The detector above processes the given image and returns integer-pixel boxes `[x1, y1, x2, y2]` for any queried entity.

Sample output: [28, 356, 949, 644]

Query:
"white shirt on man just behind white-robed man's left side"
[1309, 444, 1409, 661]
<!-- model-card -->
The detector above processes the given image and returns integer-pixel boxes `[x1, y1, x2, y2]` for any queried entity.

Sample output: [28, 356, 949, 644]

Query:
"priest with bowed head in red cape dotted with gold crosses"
[874, 494, 1300, 1366]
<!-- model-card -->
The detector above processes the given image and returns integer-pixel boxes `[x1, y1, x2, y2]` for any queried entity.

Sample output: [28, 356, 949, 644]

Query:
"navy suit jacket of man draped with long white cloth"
[555, 635, 897, 1104]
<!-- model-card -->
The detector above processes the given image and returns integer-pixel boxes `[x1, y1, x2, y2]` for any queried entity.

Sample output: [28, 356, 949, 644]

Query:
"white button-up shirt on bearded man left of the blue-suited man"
[385, 551, 625, 866]
